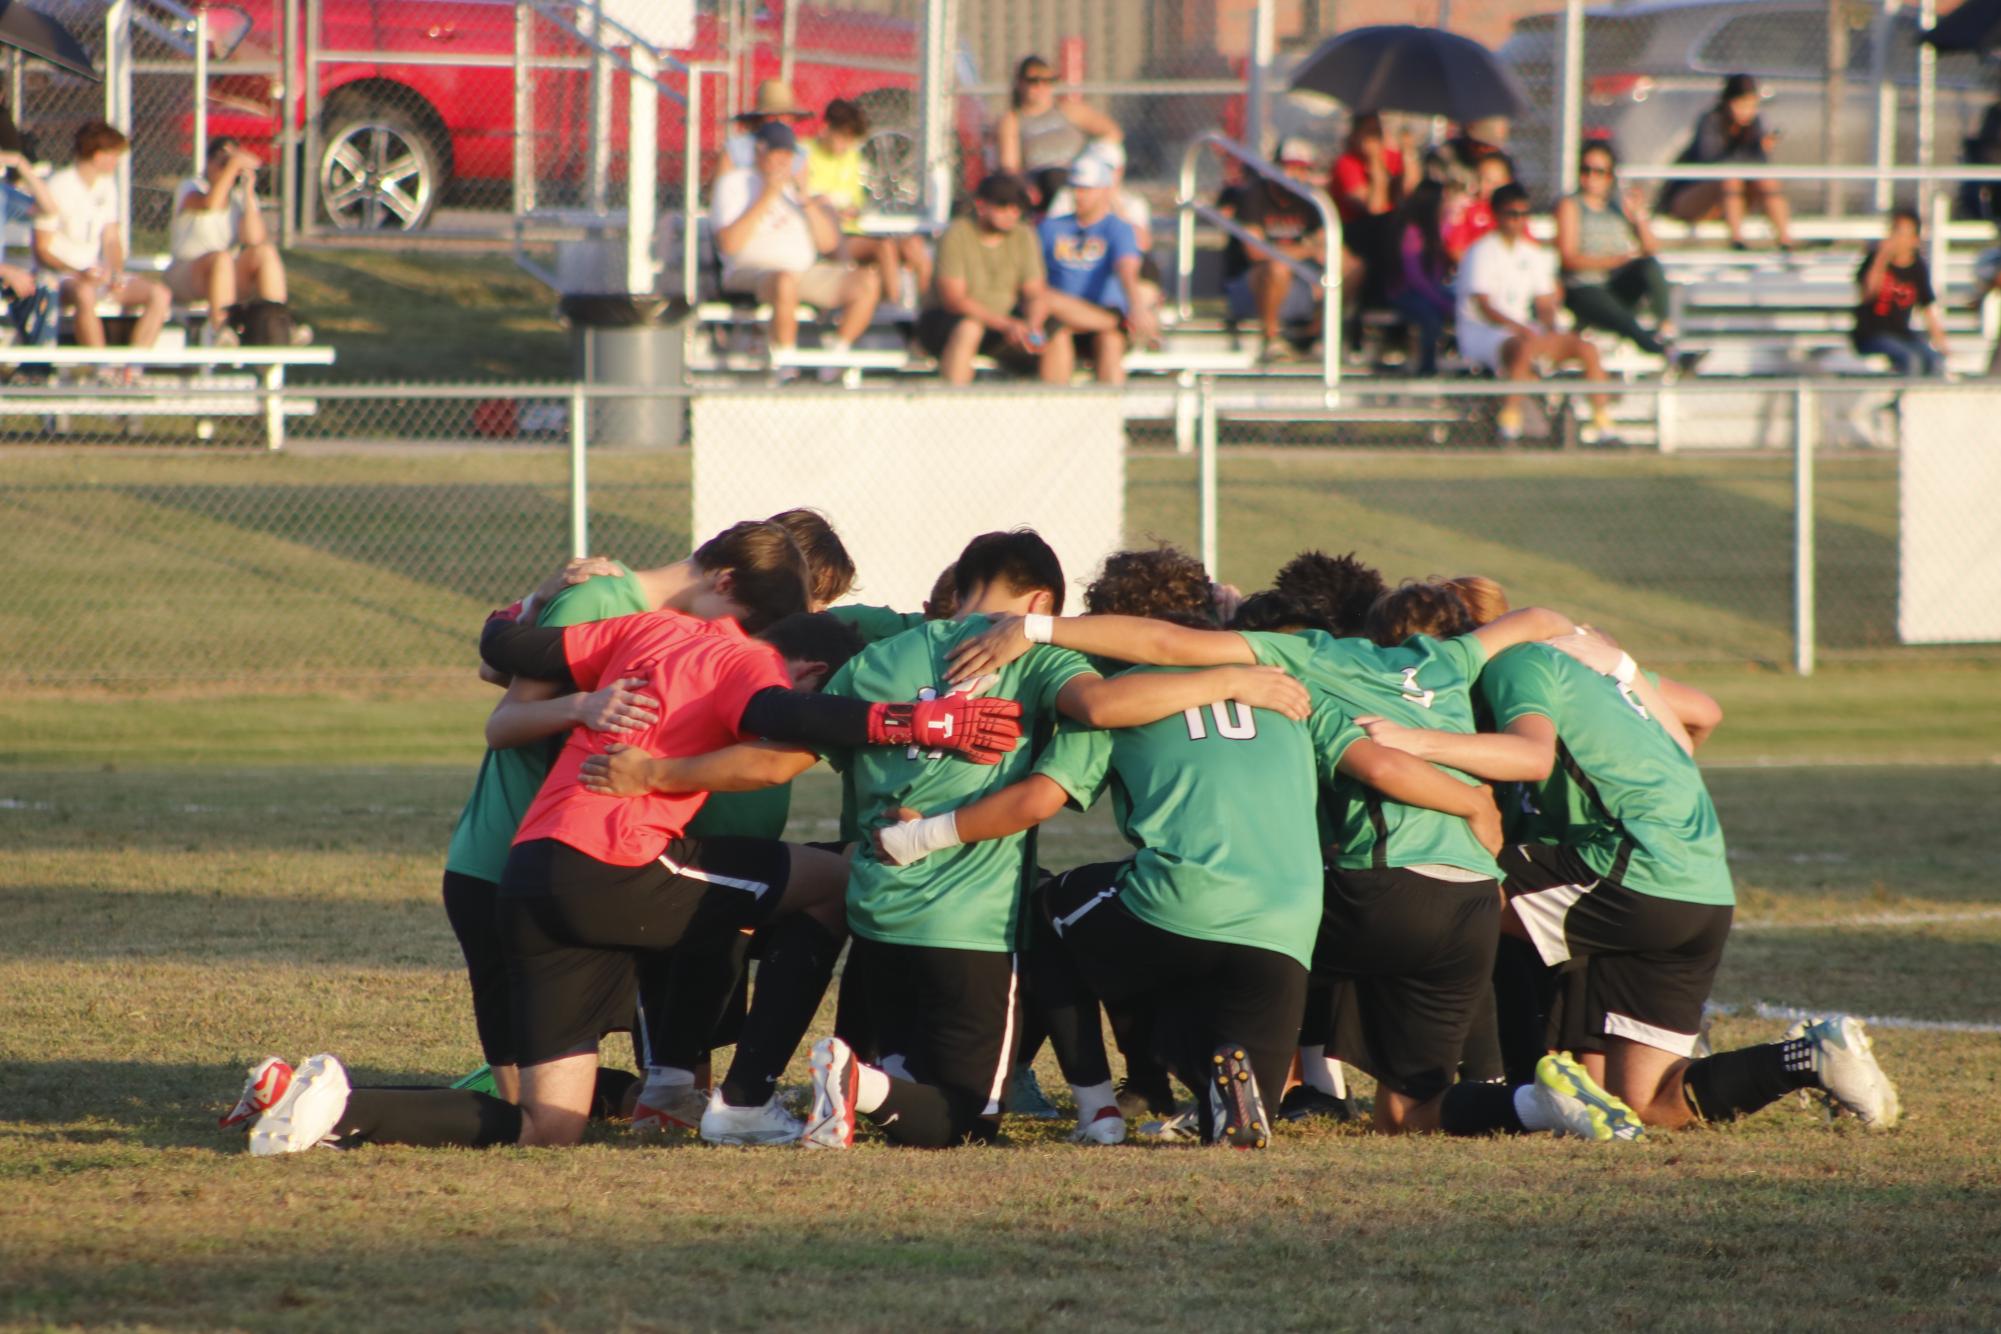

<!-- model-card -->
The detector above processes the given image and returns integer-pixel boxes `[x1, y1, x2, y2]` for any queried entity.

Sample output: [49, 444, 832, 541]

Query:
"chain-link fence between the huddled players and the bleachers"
[0, 384, 1967, 690]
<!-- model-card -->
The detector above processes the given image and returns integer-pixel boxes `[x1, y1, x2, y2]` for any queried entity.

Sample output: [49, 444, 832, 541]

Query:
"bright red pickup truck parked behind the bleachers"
[208, 0, 984, 230]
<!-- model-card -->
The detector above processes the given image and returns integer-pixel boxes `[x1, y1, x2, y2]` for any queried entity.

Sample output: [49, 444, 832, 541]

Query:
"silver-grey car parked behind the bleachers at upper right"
[1499, 0, 1995, 210]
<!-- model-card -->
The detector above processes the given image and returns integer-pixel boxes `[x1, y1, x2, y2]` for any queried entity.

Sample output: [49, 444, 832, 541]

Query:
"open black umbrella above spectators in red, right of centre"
[1293, 24, 1529, 124]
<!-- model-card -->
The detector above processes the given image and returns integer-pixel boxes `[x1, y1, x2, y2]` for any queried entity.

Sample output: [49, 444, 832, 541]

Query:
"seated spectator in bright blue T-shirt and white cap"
[1039, 152, 1159, 384]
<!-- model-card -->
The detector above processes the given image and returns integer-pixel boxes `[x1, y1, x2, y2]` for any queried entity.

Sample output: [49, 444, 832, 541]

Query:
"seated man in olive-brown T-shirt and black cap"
[916, 172, 1075, 384]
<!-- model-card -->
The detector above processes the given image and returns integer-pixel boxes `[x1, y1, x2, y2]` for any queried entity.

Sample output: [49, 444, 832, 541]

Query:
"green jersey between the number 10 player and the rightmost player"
[1245, 630, 1501, 880]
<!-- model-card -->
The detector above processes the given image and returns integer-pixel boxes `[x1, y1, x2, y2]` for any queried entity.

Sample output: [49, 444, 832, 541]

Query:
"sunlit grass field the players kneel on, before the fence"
[0, 684, 2001, 1330]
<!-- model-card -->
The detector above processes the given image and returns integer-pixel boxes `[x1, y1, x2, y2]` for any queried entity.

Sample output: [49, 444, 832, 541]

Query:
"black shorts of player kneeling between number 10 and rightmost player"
[1313, 866, 1501, 1102]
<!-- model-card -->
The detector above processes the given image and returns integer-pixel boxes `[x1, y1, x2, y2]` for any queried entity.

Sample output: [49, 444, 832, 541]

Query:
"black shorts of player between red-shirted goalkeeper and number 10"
[846, 936, 1021, 1140]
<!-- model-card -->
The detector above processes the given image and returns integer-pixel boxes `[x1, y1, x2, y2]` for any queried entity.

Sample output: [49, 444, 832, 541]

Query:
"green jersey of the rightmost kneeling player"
[1481, 644, 1737, 904]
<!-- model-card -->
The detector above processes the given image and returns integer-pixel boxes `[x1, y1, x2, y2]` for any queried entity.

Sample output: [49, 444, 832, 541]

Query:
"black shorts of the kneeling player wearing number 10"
[1037, 862, 1307, 1114]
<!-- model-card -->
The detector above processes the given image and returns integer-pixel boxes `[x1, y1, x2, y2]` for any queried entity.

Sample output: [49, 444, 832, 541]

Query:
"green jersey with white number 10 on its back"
[1037, 668, 1363, 966]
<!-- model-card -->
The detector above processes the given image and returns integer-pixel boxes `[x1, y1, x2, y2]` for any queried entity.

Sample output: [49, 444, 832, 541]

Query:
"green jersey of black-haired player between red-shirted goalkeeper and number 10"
[826, 616, 1091, 952]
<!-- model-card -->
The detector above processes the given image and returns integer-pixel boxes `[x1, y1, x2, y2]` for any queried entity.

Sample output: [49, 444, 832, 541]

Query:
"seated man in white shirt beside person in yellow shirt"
[710, 120, 882, 378]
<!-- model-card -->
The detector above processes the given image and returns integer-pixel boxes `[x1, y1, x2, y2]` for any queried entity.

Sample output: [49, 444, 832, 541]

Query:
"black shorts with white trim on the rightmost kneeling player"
[1501, 844, 1737, 1056]
